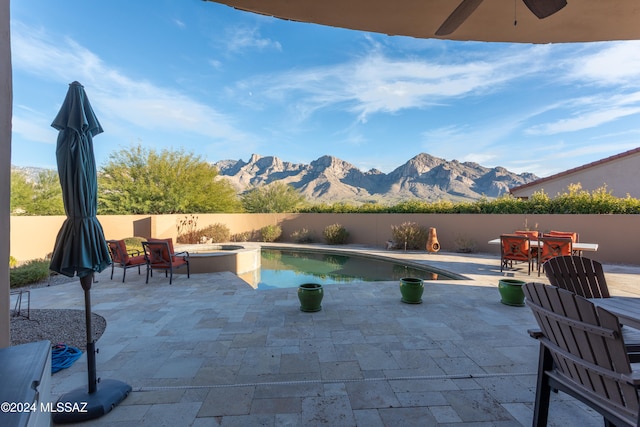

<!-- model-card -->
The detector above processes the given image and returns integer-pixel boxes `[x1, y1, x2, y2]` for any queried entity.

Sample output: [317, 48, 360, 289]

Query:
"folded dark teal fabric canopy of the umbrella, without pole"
[49, 82, 111, 279]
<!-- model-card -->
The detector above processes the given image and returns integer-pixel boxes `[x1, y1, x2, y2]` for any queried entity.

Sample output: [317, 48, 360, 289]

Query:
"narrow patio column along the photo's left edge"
[0, 0, 13, 348]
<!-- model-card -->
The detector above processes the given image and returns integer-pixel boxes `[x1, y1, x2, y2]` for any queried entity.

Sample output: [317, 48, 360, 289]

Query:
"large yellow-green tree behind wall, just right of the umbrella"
[98, 145, 242, 214]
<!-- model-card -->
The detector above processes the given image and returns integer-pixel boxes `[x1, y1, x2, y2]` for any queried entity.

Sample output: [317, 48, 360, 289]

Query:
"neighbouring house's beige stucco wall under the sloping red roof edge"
[512, 153, 640, 198]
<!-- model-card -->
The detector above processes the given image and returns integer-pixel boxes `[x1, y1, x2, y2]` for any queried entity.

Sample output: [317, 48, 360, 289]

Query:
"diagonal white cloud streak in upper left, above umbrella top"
[12, 22, 247, 142]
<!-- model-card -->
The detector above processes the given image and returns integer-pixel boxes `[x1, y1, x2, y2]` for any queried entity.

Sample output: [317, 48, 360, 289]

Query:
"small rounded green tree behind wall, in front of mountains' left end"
[241, 182, 305, 213]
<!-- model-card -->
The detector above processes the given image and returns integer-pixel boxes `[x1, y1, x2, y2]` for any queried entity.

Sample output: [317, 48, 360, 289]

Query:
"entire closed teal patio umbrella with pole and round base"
[49, 82, 131, 423]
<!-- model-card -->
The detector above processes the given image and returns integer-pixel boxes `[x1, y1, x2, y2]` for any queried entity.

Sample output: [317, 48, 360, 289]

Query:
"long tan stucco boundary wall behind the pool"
[11, 213, 640, 265]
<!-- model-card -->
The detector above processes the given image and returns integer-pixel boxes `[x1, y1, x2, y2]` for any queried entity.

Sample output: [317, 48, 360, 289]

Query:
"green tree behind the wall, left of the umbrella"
[10, 170, 64, 215]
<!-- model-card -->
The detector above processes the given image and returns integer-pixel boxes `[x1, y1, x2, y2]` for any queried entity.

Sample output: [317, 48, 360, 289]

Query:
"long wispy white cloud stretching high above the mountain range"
[238, 47, 546, 126]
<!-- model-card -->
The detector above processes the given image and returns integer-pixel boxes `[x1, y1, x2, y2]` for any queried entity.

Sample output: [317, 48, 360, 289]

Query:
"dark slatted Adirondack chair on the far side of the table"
[544, 255, 640, 362]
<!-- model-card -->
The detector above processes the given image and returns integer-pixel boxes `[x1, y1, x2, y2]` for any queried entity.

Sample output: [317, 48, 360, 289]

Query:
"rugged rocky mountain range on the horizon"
[214, 153, 538, 203]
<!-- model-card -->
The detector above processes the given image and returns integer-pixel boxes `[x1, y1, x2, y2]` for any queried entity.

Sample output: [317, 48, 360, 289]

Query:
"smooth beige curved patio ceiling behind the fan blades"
[208, 0, 640, 43]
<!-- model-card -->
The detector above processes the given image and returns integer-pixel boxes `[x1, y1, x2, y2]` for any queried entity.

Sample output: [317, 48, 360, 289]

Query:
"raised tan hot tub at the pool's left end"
[175, 243, 260, 283]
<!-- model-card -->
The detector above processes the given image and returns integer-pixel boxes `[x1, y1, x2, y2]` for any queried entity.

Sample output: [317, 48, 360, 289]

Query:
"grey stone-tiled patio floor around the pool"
[21, 247, 640, 427]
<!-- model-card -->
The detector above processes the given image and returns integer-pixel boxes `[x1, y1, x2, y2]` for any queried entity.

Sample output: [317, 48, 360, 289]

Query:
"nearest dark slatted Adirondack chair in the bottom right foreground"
[523, 283, 640, 426]
